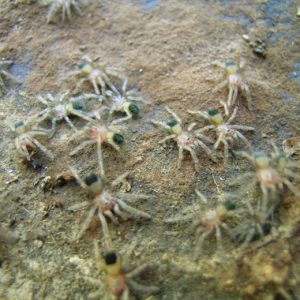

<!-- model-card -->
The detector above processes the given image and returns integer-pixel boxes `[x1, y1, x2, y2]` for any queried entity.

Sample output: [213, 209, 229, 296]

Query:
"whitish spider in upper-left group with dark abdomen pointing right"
[37, 92, 91, 137]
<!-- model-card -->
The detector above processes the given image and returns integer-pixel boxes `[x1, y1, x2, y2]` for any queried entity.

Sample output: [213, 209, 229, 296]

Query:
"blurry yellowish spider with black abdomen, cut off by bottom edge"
[84, 243, 160, 300]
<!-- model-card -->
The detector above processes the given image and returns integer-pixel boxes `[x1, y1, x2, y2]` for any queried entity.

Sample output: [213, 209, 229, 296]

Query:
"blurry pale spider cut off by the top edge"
[47, 0, 84, 24]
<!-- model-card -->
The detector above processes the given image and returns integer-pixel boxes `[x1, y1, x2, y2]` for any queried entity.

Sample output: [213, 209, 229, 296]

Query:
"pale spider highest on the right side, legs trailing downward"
[213, 59, 252, 110]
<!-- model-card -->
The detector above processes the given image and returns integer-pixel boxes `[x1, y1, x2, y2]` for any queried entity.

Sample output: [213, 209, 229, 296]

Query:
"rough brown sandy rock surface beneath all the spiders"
[0, 0, 300, 300]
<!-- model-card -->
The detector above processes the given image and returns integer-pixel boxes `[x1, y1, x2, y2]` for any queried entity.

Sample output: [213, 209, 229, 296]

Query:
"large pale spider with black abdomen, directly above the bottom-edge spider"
[68, 168, 153, 244]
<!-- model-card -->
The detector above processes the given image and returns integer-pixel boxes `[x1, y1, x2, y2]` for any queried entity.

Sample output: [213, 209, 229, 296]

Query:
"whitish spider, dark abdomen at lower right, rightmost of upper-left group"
[107, 80, 147, 124]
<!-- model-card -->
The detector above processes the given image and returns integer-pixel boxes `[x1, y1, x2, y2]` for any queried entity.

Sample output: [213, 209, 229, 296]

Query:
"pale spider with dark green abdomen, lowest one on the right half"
[165, 189, 236, 258]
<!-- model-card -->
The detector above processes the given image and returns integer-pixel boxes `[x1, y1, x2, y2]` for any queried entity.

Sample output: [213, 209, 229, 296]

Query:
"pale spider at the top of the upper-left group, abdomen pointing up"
[71, 55, 125, 96]
